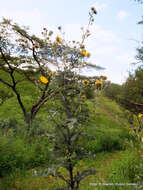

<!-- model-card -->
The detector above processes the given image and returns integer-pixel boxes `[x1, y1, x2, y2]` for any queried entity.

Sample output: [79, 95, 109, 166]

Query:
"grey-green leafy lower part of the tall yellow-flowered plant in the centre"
[44, 68, 96, 190]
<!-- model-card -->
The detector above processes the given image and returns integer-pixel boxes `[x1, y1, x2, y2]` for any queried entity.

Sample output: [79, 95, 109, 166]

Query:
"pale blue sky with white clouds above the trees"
[0, 0, 143, 84]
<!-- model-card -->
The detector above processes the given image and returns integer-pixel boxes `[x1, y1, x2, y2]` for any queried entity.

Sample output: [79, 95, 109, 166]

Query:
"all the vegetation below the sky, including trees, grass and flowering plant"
[0, 2, 143, 190]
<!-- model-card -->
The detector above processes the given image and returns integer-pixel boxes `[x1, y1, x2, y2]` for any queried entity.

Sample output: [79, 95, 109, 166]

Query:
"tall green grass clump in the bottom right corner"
[92, 149, 140, 190]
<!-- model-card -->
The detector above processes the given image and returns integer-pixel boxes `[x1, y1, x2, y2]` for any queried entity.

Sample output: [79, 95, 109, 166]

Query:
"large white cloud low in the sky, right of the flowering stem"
[45, 24, 134, 84]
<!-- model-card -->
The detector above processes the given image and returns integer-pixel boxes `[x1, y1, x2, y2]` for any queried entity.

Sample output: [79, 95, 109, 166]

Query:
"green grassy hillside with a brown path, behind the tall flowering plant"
[0, 73, 139, 190]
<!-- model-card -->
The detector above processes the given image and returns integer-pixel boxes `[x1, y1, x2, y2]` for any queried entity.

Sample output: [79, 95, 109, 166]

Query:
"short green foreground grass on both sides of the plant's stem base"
[0, 150, 138, 190]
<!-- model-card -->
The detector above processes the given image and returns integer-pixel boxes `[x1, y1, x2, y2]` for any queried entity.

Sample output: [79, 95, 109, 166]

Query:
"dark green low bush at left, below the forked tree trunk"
[0, 136, 50, 176]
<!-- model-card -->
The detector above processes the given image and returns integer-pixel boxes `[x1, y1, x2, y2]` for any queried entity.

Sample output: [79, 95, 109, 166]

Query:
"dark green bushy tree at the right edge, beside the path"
[115, 67, 143, 143]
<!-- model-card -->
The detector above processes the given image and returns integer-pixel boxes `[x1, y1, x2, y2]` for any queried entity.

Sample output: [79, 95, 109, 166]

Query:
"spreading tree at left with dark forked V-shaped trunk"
[0, 19, 57, 128]
